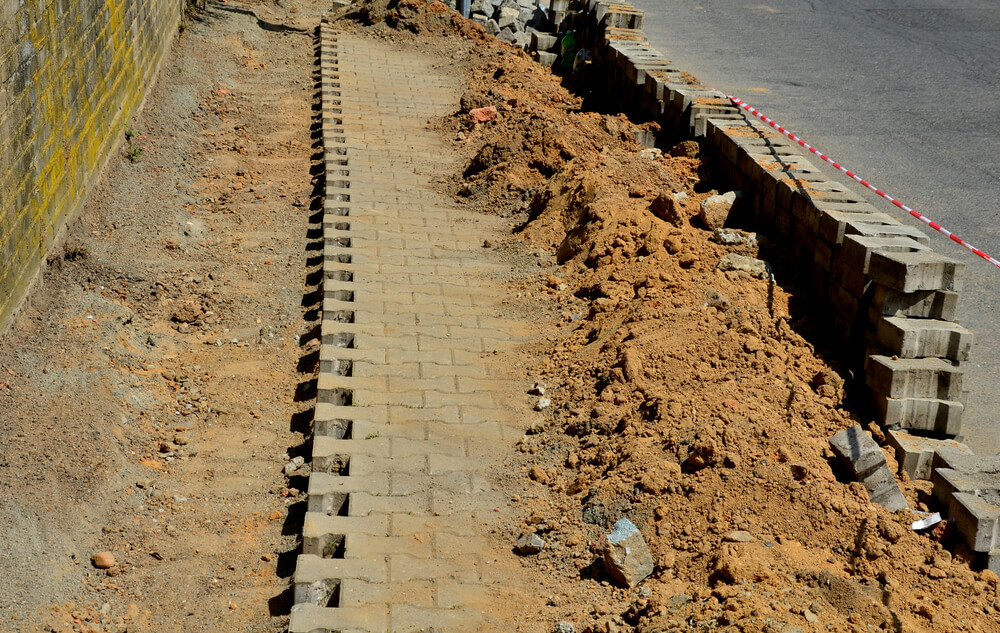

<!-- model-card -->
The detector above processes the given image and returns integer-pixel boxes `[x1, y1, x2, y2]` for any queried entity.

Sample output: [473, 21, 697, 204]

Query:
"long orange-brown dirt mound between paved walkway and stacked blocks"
[406, 6, 997, 632]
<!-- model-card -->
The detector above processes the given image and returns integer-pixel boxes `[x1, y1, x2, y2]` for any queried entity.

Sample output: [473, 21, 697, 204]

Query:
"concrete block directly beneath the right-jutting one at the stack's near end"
[865, 354, 962, 400]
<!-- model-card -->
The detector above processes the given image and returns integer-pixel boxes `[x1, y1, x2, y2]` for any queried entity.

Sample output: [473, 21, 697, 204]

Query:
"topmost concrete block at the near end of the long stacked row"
[868, 250, 965, 292]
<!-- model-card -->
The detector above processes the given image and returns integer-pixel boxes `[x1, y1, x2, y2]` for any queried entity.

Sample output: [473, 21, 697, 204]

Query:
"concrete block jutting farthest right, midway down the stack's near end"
[877, 317, 972, 361]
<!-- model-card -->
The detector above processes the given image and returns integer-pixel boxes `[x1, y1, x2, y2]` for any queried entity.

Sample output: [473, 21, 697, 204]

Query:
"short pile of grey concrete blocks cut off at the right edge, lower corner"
[888, 431, 1000, 573]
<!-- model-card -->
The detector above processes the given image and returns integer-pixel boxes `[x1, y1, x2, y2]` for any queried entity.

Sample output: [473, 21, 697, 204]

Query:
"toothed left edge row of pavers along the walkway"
[288, 21, 360, 633]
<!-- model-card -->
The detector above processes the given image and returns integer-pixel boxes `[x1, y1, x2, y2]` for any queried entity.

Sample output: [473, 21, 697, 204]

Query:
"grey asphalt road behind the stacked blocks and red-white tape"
[630, 0, 1000, 454]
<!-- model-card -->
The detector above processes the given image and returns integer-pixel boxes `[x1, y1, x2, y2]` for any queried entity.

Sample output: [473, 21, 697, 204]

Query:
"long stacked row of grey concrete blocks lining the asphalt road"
[560, 0, 972, 435]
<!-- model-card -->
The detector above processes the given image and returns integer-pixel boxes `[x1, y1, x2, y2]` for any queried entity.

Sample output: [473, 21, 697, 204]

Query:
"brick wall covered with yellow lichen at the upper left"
[0, 0, 183, 329]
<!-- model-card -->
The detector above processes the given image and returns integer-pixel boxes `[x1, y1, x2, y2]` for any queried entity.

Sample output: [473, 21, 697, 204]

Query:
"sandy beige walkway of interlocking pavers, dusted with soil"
[290, 24, 521, 633]
